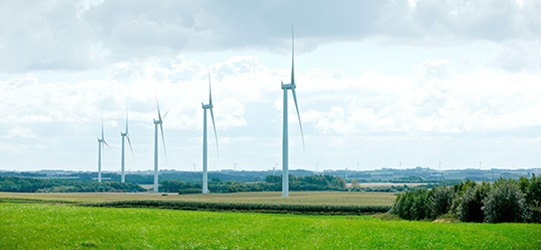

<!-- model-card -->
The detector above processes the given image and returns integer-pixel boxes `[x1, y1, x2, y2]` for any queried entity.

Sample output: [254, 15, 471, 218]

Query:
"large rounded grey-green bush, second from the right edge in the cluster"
[483, 179, 524, 223]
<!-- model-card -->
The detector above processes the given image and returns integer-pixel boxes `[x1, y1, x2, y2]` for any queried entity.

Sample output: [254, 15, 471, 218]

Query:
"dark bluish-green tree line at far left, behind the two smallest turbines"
[0, 177, 146, 193]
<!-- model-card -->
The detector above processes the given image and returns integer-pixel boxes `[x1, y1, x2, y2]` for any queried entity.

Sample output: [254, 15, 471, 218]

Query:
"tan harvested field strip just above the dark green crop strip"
[0, 192, 396, 206]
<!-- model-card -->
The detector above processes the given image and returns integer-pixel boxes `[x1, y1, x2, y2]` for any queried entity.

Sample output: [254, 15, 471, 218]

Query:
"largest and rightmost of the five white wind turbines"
[282, 26, 304, 197]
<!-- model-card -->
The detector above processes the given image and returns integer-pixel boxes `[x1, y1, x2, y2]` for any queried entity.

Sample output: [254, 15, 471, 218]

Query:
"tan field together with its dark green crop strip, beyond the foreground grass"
[0, 192, 394, 215]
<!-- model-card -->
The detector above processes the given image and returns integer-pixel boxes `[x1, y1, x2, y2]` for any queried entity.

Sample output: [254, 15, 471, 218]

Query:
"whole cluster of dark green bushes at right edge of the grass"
[391, 175, 541, 223]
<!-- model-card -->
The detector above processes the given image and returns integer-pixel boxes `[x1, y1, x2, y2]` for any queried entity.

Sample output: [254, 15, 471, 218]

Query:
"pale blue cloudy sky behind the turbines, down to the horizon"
[0, 0, 541, 171]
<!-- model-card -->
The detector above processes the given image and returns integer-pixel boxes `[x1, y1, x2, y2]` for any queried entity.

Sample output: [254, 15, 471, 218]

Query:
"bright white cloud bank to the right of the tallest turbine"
[303, 61, 541, 135]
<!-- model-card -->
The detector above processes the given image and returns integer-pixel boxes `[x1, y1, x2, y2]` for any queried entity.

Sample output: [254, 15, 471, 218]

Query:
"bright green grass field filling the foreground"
[0, 203, 541, 249]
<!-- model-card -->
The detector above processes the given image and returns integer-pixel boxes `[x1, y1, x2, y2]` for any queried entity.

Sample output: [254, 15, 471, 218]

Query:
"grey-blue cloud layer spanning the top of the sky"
[0, 0, 541, 72]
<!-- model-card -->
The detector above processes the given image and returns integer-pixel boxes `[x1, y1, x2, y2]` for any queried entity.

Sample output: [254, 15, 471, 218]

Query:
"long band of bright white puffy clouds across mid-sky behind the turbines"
[0, 57, 541, 139]
